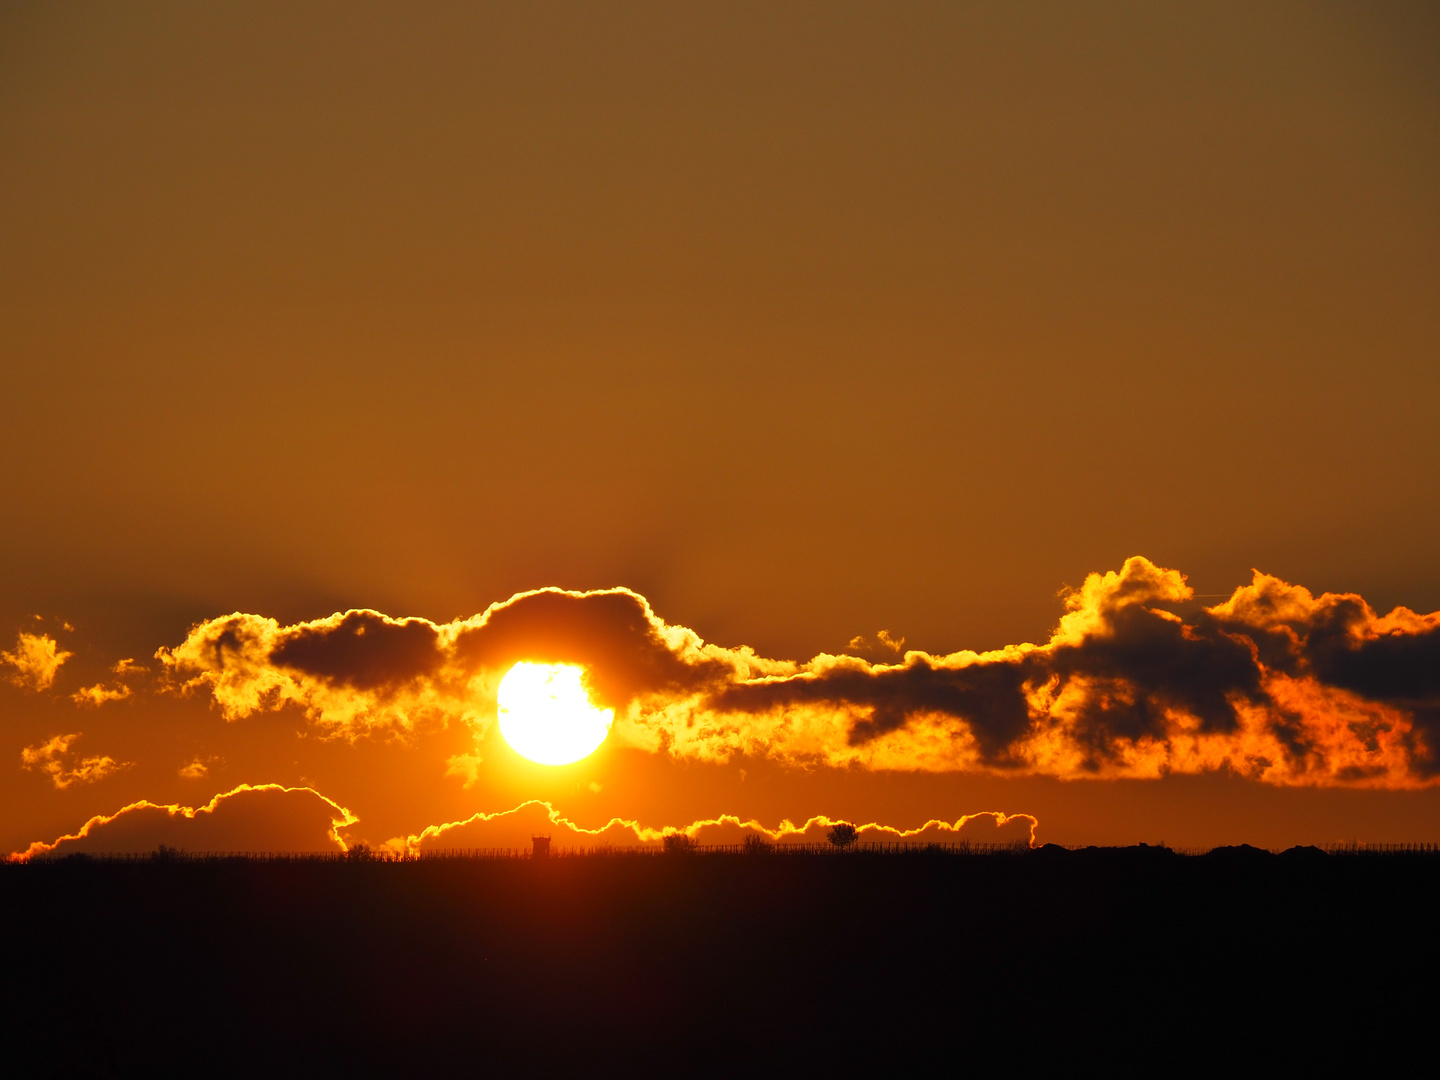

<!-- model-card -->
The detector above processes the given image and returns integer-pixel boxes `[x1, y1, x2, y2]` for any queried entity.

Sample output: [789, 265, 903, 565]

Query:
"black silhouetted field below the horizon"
[0, 848, 1440, 1076]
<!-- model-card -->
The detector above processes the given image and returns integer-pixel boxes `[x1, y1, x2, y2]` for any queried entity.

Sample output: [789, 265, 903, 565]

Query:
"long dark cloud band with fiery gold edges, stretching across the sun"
[158, 557, 1440, 788]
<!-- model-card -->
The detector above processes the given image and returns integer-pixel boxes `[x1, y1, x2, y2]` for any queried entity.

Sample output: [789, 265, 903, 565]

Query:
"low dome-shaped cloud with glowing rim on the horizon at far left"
[12, 783, 359, 860]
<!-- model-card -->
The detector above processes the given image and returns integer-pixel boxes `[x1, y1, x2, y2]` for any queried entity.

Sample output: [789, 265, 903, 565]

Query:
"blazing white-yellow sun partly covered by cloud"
[497, 661, 615, 765]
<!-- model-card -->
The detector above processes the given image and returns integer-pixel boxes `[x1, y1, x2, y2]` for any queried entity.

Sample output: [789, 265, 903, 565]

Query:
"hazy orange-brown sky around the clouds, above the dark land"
[0, 3, 1440, 851]
